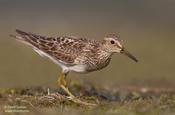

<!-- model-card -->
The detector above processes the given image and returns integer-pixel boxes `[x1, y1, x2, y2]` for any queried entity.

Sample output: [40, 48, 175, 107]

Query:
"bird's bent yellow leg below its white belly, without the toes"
[58, 73, 75, 98]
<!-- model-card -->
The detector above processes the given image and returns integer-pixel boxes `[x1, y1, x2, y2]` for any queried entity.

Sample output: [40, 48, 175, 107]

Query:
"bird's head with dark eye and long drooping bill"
[103, 34, 138, 62]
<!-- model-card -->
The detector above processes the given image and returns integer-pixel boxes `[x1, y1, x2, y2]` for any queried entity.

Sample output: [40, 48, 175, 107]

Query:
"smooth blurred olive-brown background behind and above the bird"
[0, 0, 175, 88]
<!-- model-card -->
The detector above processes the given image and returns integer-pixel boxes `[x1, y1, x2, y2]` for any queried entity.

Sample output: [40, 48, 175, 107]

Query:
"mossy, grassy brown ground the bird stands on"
[0, 84, 175, 115]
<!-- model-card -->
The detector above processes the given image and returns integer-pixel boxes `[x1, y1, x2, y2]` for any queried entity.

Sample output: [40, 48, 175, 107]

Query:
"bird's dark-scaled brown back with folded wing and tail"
[12, 30, 98, 66]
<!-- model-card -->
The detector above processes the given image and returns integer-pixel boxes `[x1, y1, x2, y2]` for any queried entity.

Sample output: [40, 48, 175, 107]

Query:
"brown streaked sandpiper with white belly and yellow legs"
[11, 29, 138, 105]
